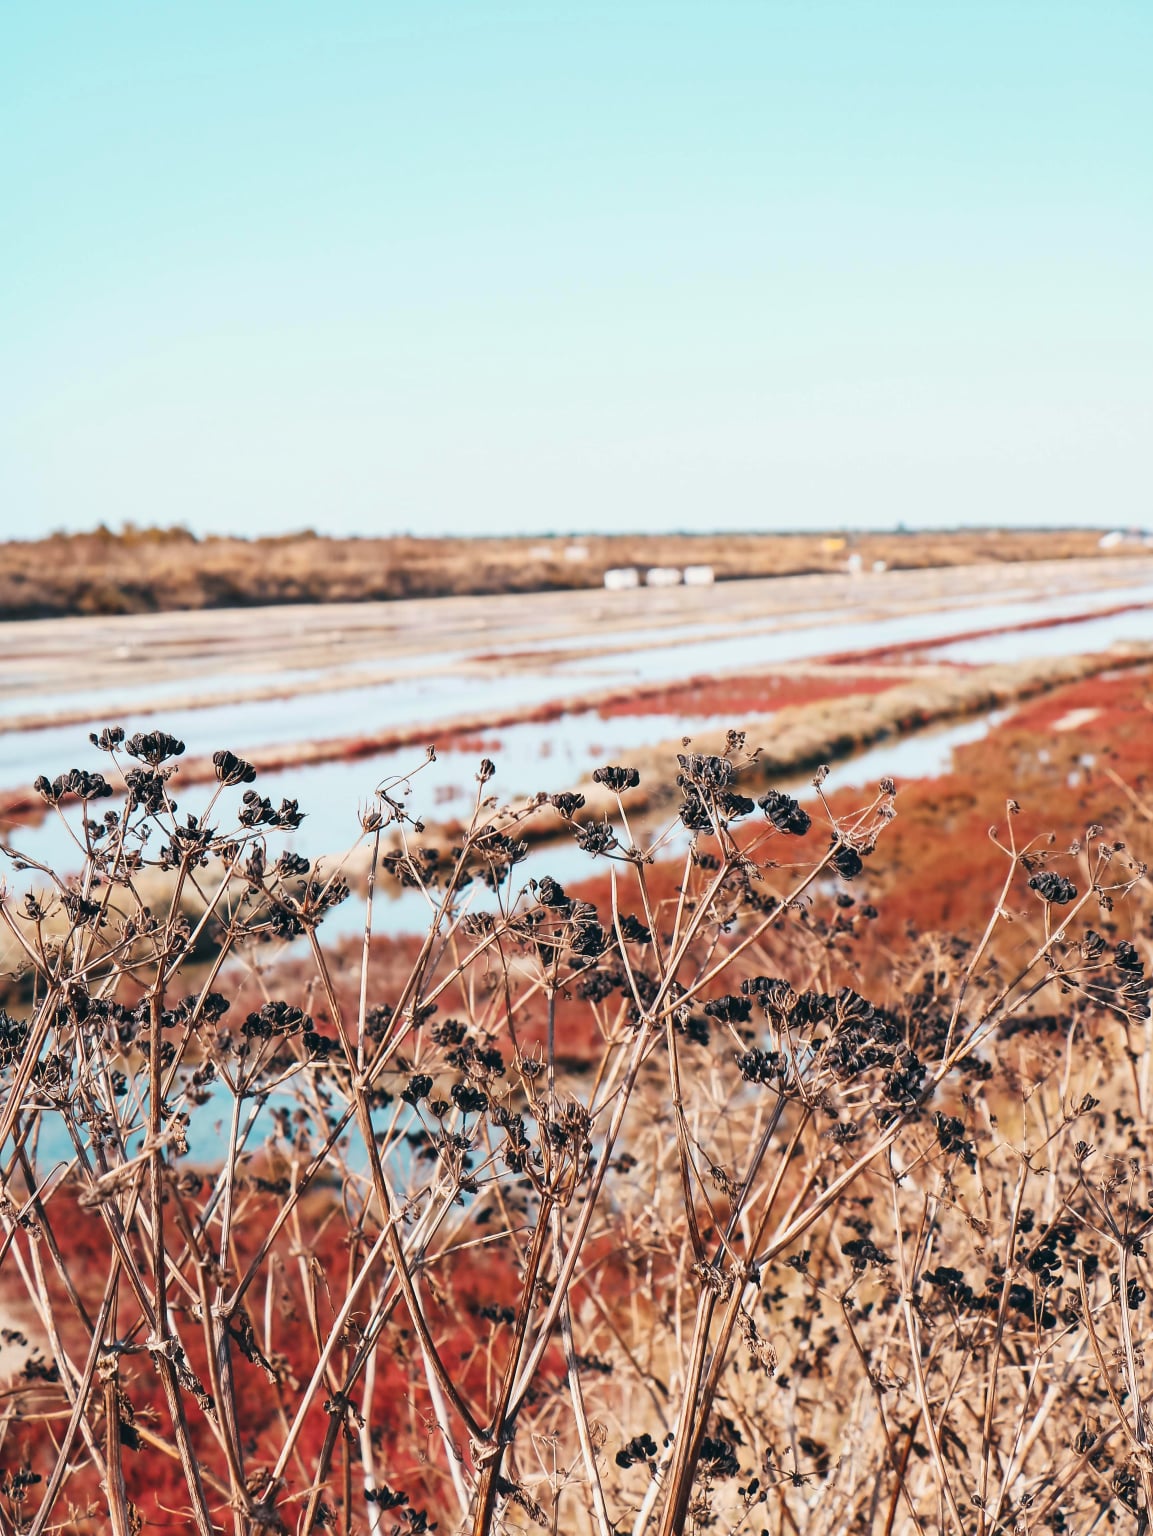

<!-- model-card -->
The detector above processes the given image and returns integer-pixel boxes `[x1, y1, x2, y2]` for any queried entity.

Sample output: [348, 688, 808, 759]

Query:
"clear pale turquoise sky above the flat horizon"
[0, 0, 1153, 536]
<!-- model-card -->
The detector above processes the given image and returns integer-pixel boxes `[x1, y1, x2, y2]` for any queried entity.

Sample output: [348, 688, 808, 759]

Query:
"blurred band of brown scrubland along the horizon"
[0, 527, 1150, 619]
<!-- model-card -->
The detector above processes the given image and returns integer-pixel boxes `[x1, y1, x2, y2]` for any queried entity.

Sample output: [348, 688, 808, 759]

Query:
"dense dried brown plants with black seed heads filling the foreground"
[0, 728, 1153, 1536]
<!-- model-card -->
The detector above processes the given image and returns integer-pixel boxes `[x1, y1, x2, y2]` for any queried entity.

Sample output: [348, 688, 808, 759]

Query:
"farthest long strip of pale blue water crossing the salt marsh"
[0, 582, 1153, 768]
